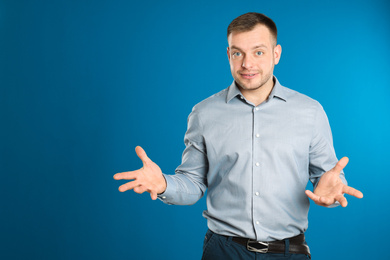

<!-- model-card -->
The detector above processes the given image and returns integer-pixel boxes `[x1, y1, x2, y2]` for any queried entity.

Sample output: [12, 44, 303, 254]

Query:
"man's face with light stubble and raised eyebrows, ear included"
[227, 24, 282, 90]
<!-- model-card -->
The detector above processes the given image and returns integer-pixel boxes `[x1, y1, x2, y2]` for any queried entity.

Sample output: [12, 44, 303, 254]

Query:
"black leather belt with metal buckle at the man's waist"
[232, 234, 310, 257]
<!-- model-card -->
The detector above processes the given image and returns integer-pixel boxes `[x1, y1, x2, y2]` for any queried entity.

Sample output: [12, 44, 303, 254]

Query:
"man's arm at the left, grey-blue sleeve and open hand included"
[114, 106, 208, 205]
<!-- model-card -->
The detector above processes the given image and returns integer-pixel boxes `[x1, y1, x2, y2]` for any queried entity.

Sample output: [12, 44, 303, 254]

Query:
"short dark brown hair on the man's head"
[227, 12, 278, 44]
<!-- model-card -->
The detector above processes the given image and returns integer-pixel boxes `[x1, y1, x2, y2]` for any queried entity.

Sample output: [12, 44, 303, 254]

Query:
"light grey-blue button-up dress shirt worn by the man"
[159, 78, 346, 241]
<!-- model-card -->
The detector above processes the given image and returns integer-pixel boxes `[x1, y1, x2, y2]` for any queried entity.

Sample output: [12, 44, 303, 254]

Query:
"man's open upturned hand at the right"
[305, 157, 363, 207]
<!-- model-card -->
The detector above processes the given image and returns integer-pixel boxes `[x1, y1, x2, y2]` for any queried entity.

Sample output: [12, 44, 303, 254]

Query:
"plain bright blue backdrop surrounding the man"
[0, 0, 390, 260]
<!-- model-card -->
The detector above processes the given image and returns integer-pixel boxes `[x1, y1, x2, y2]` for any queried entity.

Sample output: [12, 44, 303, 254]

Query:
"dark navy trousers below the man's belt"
[202, 230, 310, 260]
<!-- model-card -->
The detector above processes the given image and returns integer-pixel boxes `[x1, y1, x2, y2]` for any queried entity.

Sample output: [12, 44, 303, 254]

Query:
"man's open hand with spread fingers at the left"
[114, 146, 167, 200]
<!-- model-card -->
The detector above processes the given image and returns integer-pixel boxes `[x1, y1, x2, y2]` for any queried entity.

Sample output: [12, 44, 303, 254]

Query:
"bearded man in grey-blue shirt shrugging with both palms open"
[114, 13, 363, 260]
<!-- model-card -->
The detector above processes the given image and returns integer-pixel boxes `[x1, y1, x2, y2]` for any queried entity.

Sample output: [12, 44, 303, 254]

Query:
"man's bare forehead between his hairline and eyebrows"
[228, 24, 272, 49]
